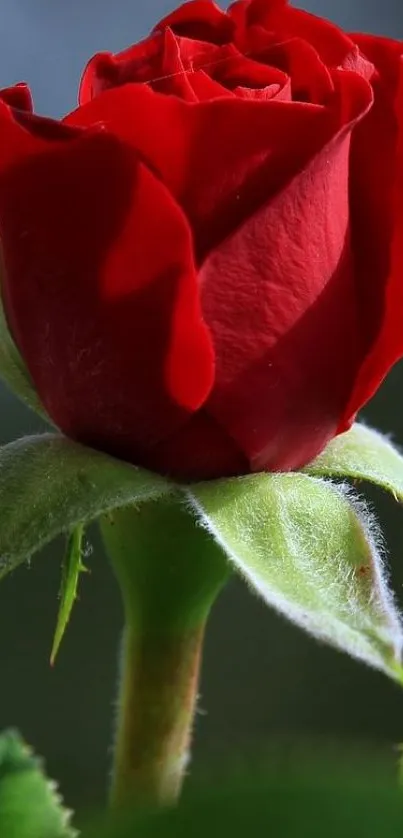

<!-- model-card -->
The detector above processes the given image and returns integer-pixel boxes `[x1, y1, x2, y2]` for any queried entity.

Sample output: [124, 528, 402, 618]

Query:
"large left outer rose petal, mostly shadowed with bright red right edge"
[0, 105, 214, 464]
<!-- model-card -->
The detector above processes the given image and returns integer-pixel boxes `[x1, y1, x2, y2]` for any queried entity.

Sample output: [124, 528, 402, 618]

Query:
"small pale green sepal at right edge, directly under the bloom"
[303, 424, 403, 501]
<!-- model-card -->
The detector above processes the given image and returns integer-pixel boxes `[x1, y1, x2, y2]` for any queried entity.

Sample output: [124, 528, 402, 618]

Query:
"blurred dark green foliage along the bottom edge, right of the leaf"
[82, 765, 403, 838]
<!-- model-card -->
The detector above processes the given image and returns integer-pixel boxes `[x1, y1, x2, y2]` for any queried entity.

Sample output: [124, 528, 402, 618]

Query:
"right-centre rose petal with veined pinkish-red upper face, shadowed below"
[201, 72, 371, 470]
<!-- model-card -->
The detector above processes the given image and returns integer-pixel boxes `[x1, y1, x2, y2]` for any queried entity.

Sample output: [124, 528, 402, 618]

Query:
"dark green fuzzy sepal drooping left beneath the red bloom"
[0, 434, 172, 578]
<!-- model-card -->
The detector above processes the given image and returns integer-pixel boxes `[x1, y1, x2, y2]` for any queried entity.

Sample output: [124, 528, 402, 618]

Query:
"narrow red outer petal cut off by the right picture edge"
[339, 36, 403, 431]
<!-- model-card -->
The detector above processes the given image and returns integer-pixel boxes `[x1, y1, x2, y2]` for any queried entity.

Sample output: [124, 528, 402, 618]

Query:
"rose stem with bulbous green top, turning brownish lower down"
[101, 500, 229, 806]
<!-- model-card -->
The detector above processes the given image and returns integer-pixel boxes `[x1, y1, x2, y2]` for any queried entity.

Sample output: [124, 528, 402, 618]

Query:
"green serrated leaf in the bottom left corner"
[0, 731, 78, 838]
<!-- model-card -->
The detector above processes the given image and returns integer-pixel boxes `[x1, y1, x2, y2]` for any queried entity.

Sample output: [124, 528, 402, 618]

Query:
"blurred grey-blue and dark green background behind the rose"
[0, 0, 403, 816]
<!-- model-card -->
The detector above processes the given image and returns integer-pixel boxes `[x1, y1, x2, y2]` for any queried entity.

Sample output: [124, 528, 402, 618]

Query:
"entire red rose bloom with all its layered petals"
[0, 0, 403, 479]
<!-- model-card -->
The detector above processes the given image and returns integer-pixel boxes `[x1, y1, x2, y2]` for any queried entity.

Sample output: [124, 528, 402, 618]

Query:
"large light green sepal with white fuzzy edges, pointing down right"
[189, 473, 403, 680]
